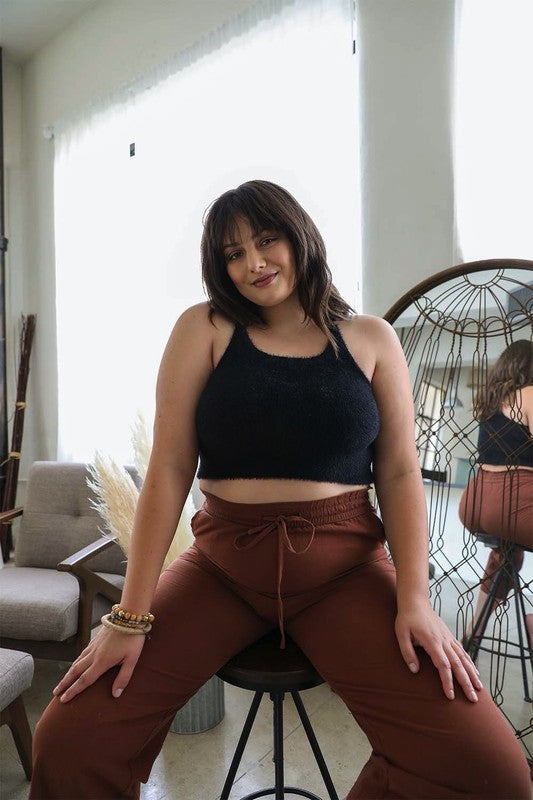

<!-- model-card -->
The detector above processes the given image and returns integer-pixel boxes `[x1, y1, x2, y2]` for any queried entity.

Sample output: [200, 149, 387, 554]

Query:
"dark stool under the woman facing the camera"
[217, 631, 339, 800]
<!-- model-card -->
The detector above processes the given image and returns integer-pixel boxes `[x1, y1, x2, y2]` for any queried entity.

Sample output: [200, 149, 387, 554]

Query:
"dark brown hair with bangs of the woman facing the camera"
[201, 180, 355, 351]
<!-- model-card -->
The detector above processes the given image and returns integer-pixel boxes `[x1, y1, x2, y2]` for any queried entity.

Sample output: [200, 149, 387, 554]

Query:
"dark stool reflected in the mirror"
[464, 533, 533, 702]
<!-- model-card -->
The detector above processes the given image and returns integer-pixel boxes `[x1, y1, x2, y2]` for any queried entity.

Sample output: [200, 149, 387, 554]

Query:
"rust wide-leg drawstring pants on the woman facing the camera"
[30, 491, 531, 800]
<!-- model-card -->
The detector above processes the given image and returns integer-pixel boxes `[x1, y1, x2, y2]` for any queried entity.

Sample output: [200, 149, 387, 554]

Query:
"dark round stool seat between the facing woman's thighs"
[217, 631, 324, 692]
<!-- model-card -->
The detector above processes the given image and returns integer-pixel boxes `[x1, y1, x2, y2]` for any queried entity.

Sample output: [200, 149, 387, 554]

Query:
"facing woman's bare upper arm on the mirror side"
[356, 317, 420, 483]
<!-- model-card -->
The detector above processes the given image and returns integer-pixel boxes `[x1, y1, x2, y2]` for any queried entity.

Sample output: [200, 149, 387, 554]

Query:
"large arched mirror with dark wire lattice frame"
[385, 260, 533, 759]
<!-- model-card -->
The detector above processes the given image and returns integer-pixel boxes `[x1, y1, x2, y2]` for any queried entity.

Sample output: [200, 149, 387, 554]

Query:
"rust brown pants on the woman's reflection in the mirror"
[459, 469, 533, 600]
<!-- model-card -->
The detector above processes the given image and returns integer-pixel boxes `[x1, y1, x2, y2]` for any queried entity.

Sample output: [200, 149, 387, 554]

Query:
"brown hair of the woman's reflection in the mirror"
[474, 339, 533, 421]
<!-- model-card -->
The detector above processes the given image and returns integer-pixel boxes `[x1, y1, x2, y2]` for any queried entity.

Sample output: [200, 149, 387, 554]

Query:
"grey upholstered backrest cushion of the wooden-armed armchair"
[15, 461, 126, 575]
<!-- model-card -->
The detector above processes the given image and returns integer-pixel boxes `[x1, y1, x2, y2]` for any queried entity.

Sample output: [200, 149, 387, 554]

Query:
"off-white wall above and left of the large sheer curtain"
[4, 0, 260, 482]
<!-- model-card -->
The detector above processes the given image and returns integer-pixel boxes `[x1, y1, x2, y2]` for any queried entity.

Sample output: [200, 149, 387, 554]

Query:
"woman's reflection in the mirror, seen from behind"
[459, 339, 533, 642]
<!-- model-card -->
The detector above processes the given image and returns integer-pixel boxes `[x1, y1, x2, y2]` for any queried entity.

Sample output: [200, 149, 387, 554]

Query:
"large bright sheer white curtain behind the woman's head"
[55, 0, 360, 461]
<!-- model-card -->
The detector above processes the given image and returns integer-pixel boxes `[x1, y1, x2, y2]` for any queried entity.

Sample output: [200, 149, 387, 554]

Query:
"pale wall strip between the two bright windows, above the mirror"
[356, 0, 454, 315]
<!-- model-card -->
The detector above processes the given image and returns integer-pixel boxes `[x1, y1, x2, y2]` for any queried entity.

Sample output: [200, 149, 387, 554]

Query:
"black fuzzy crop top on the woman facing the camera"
[196, 325, 379, 484]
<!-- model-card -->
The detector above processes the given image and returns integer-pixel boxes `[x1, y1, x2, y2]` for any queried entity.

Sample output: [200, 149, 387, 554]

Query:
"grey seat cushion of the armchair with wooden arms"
[0, 567, 124, 642]
